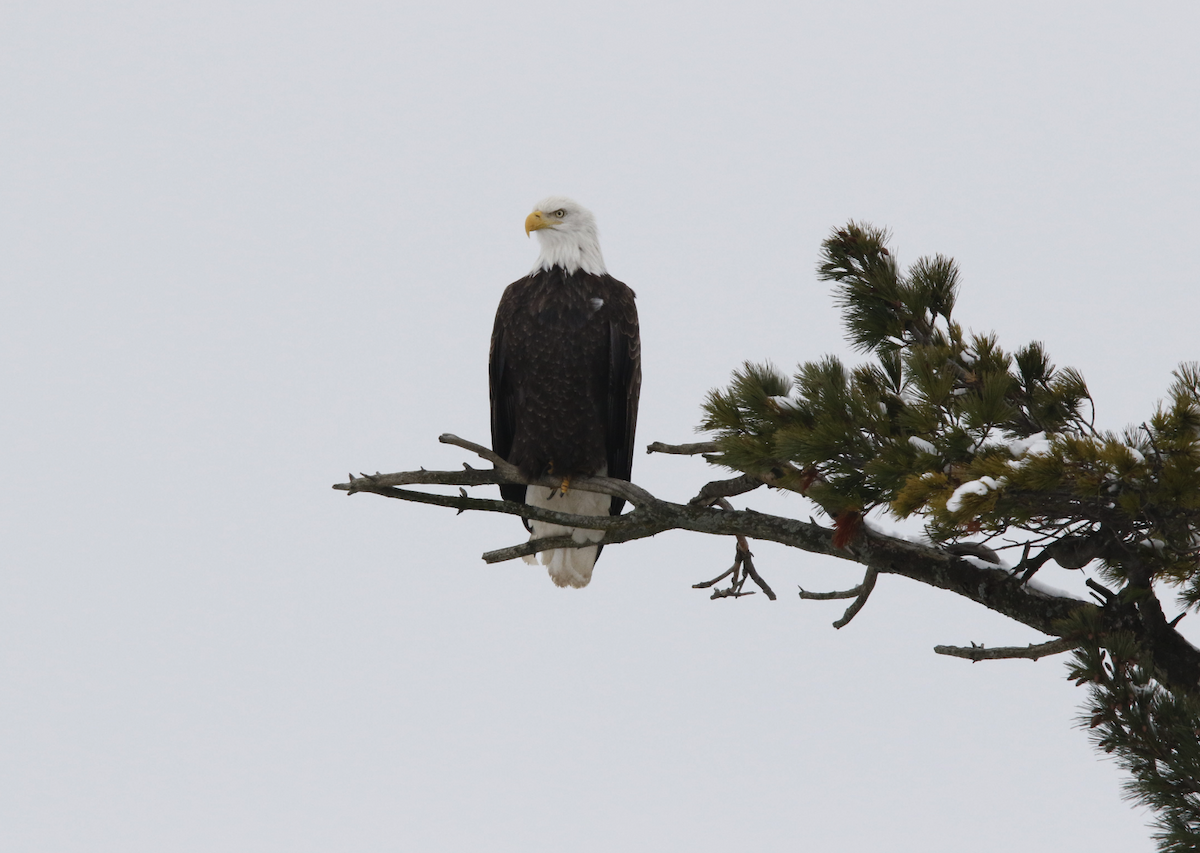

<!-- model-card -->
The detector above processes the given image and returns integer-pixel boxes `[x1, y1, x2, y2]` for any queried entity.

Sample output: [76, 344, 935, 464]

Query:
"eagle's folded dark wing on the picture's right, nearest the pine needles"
[605, 281, 642, 516]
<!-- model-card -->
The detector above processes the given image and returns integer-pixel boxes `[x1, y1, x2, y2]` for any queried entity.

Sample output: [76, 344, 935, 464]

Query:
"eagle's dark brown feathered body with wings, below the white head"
[490, 266, 642, 515]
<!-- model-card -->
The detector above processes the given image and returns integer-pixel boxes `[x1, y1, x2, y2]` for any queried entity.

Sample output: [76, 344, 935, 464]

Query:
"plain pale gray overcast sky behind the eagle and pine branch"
[0, 0, 1200, 853]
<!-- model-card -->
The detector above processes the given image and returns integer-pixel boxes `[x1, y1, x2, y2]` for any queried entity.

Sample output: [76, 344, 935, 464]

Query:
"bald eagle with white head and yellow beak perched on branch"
[488, 197, 642, 587]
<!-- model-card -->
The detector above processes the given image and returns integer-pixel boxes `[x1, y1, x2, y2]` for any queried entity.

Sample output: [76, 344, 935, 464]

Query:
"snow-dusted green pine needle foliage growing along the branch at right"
[701, 222, 1200, 851]
